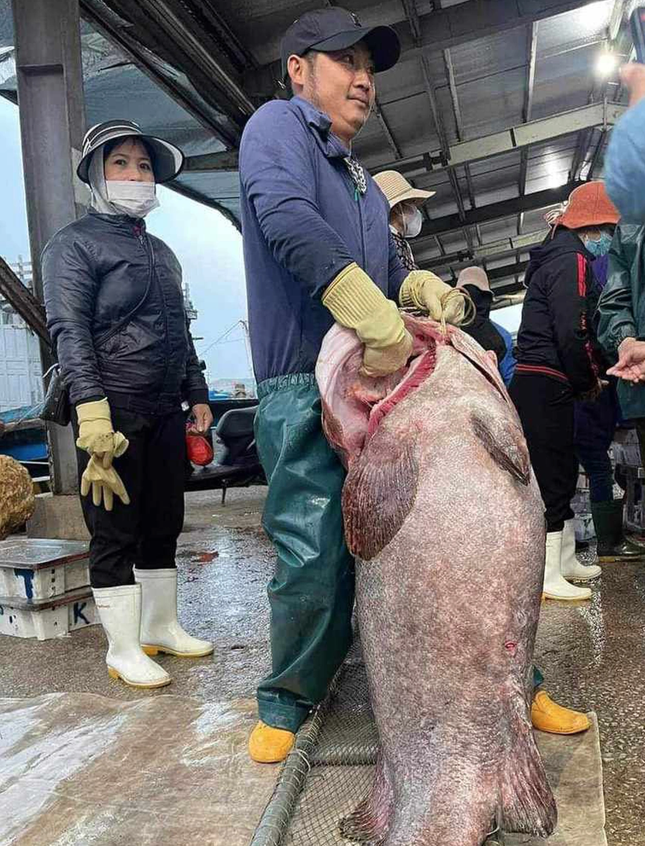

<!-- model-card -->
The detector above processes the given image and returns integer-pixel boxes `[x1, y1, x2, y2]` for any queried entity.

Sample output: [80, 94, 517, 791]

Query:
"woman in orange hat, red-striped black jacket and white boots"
[510, 182, 618, 600]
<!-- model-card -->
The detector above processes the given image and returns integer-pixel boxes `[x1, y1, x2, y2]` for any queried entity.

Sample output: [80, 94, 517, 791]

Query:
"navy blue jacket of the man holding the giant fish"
[240, 97, 408, 382]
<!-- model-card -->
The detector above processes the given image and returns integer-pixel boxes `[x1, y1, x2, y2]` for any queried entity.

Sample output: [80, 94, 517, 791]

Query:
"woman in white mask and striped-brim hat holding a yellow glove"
[42, 121, 213, 688]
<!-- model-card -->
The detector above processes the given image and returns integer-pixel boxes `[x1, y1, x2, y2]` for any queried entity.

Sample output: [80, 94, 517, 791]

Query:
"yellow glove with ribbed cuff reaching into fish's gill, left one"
[322, 263, 412, 377]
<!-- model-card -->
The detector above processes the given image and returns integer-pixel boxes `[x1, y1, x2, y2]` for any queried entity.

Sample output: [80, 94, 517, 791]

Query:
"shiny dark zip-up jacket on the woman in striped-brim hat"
[42, 213, 208, 414]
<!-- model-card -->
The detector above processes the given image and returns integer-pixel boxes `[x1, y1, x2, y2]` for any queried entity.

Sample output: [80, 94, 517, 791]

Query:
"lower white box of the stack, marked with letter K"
[0, 588, 99, 640]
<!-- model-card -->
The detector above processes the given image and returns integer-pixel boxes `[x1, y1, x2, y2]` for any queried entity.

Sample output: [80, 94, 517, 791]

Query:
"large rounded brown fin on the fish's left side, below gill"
[343, 427, 419, 561]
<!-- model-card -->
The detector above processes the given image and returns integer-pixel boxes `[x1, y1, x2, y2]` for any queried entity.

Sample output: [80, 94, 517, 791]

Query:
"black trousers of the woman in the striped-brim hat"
[72, 407, 186, 588]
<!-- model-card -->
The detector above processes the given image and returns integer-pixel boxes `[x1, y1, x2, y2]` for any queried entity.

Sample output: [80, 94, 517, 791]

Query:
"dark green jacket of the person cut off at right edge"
[598, 224, 645, 420]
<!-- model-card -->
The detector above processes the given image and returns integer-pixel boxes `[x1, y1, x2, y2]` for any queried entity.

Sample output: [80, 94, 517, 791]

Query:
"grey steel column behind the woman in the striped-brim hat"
[12, 0, 85, 494]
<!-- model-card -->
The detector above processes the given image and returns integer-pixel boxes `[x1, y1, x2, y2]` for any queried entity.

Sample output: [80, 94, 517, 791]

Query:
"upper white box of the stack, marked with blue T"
[0, 538, 90, 602]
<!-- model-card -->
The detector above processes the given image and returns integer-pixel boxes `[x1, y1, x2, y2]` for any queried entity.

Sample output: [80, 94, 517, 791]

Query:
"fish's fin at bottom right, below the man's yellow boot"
[499, 700, 558, 837]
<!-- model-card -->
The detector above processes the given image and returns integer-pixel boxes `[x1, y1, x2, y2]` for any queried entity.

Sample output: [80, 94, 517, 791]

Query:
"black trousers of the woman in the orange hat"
[509, 373, 578, 532]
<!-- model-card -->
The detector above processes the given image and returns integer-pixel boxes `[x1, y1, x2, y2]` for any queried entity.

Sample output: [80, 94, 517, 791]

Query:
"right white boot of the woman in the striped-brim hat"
[134, 567, 213, 658]
